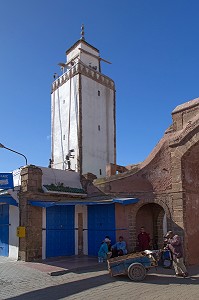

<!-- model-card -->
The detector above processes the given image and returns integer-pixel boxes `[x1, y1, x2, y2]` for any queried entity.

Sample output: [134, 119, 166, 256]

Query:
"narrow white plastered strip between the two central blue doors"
[75, 205, 88, 255]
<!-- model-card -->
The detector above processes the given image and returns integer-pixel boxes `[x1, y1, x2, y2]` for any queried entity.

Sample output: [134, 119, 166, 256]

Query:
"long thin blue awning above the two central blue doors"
[28, 198, 139, 207]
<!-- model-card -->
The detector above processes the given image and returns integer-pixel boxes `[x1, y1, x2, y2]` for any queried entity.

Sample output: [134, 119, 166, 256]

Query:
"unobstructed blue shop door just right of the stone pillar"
[46, 206, 75, 257]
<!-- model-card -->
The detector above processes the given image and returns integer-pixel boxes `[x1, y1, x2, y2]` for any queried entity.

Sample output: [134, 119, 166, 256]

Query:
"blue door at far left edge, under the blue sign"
[0, 204, 9, 256]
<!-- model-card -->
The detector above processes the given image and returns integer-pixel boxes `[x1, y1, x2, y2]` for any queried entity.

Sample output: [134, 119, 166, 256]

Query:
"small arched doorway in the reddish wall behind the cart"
[136, 203, 167, 249]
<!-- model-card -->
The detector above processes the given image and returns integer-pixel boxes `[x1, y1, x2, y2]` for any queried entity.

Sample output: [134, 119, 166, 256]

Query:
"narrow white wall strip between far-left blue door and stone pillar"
[9, 205, 19, 260]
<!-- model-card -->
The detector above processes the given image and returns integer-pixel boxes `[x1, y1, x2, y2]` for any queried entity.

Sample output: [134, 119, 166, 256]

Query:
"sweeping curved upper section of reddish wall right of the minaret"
[94, 139, 171, 194]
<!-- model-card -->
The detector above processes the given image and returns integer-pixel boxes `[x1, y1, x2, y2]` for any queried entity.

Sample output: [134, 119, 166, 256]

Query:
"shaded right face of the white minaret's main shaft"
[82, 76, 115, 177]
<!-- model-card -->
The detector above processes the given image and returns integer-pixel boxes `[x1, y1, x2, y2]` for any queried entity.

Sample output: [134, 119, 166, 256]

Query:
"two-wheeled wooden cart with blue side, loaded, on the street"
[107, 252, 158, 281]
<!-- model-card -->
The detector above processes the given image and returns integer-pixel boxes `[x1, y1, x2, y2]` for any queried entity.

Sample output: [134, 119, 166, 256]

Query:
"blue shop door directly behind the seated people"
[88, 204, 115, 256]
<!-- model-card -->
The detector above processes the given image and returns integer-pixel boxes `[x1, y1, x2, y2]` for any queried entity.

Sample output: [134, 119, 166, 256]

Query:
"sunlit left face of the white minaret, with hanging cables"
[51, 76, 79, 171]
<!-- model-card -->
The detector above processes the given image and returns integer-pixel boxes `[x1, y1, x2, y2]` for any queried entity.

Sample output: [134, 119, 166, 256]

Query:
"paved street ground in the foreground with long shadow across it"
[0, 258, 199, 300]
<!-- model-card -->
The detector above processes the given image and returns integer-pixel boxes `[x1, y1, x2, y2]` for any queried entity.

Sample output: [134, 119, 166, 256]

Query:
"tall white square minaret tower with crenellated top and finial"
[51, 26, 116, 177]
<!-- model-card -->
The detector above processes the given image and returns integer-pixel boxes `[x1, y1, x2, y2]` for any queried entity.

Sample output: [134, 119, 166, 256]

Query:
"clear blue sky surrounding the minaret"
[0, 0, 199, 172]
